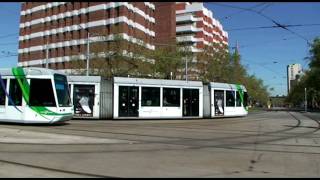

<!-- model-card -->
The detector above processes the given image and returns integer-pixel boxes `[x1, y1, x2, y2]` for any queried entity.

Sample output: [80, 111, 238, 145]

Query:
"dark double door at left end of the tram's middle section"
[119, 86, 139, 117]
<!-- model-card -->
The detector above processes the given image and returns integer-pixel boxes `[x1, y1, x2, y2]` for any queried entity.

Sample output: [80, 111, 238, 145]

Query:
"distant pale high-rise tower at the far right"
[287, 64, 303, 94]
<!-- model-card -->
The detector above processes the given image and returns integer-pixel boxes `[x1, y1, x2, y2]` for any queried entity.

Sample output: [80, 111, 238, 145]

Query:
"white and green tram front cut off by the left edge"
[0, 67, 73, 124]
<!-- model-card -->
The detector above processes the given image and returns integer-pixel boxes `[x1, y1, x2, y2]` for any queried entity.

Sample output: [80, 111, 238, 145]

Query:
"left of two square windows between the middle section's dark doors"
[141, 87, 160, 106]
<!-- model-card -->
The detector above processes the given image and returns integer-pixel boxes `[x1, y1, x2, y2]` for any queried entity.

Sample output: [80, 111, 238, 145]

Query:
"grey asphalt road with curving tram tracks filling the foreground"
[0, 111, 320, 177]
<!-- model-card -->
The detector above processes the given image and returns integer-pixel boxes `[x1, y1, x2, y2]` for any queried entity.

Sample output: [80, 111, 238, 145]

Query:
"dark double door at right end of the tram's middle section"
[183, 89, 199, 116]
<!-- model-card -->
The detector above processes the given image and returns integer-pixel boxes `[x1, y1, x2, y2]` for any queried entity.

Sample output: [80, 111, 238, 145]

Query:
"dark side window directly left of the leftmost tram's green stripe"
[9, 79, 22, 106]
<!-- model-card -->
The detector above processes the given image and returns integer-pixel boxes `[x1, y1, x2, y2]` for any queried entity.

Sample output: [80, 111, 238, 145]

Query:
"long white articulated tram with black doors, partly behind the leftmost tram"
[68, 76, 248, 119]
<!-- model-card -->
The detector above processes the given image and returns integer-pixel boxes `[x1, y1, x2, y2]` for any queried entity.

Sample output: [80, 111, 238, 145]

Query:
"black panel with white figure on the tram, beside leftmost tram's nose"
[73, 85, 95, 117]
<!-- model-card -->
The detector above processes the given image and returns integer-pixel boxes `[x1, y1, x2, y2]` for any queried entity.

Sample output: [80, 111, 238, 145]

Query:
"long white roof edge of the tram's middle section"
[113, 77, 202, 87]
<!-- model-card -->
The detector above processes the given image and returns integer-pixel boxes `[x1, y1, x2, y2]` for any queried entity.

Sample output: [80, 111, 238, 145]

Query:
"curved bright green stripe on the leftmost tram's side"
[12, 67, 71, 116]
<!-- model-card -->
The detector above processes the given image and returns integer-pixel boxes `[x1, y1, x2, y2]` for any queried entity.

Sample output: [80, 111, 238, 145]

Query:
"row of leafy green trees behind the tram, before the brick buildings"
[71, 31, 268, 105]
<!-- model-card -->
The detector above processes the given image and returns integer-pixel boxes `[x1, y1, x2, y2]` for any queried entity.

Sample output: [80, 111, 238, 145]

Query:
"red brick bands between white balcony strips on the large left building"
[18, 2, 155, 68]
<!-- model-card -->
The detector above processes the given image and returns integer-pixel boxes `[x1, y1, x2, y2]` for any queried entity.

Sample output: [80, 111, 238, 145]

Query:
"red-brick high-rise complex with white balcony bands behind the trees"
[18, 2, 228, 79]
